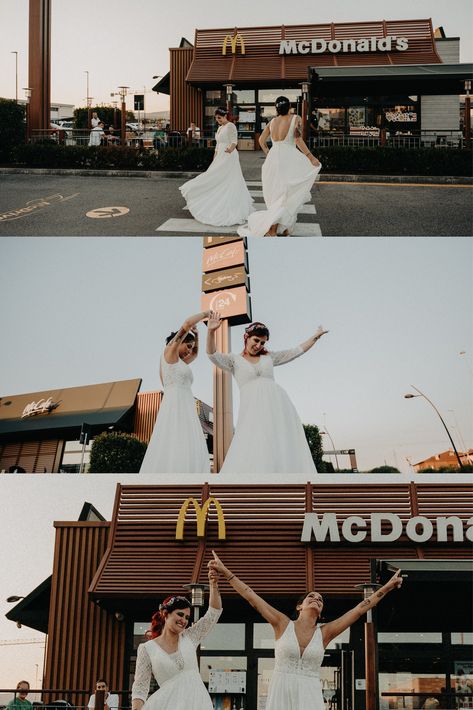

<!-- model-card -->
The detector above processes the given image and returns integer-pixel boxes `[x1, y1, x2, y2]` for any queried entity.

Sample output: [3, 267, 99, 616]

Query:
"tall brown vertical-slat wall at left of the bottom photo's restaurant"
[43, 522, 126, 706]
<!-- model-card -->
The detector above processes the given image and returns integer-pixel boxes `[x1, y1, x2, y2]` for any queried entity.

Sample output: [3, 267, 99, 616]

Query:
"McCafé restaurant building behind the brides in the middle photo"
[0, 378, 213, 473]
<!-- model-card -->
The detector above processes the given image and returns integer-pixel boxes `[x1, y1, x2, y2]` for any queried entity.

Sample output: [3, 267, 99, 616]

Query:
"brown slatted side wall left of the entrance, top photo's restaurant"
[169, 47, 204, 131]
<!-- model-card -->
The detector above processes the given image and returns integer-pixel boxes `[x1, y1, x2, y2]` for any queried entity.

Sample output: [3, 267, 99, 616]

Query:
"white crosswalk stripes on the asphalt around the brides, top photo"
[156, 181, 322, 237]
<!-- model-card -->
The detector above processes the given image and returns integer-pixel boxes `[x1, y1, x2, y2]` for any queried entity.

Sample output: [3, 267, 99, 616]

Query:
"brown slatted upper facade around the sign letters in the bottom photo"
[89, 483, 473, 599]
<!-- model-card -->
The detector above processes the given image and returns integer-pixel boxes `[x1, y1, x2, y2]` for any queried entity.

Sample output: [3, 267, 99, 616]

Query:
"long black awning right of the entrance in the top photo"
[309, 63, 473, 96]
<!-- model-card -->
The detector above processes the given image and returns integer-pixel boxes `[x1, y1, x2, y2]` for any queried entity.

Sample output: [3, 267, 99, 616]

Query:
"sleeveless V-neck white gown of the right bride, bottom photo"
[266, 621, 325, 710]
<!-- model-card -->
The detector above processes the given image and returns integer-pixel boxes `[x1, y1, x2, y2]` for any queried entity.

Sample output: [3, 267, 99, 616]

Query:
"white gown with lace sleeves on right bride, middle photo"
[209, 346, 317, 474]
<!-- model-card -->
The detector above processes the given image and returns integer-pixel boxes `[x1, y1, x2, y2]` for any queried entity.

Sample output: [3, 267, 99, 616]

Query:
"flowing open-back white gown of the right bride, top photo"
[238, 115, 322, 237]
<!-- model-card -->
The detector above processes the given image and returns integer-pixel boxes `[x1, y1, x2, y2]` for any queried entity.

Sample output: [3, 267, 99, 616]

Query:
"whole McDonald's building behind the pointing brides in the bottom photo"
[7, 479, 473, 710]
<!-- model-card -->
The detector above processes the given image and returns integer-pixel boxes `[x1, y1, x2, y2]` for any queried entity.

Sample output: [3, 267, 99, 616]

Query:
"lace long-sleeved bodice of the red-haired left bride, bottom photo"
[131, 607, 222, 701]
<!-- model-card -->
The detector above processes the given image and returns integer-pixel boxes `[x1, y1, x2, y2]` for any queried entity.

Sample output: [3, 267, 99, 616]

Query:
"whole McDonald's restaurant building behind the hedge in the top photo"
[153, 19, 472, 150]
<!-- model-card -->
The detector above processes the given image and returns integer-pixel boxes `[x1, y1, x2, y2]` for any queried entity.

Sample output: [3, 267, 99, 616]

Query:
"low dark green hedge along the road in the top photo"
[7, 141, 472, 176]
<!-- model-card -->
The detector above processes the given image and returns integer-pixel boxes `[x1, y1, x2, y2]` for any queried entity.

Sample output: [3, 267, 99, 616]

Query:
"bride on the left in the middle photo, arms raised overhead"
[140, 311, 210, 473]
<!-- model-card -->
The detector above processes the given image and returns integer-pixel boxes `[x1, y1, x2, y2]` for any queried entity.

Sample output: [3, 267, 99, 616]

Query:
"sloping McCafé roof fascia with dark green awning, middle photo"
[0, 379, 141, 440]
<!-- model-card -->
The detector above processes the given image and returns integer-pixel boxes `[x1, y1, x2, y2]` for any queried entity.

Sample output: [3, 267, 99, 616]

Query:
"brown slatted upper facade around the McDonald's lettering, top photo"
[186, 19, 442, 85]
